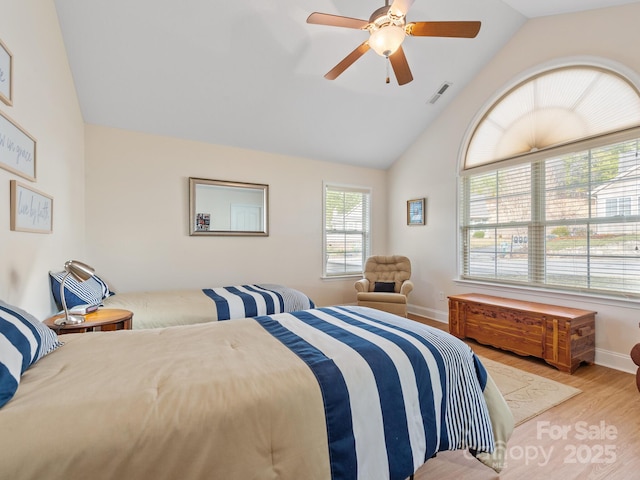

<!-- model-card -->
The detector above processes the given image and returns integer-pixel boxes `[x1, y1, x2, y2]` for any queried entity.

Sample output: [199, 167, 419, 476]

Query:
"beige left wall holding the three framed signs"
[0, 0, 85, 319]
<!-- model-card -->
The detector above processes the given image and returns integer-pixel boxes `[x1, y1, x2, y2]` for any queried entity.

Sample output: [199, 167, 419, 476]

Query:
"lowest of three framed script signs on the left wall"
[11, 180, 53, 233]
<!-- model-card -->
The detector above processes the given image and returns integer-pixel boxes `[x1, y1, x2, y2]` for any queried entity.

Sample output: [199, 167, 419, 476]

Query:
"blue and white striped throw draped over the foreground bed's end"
[255, 307, 495, 480]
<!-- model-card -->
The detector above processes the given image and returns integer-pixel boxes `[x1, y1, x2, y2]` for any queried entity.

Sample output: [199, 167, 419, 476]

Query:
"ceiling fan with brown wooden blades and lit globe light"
[307, 0, 480, 85]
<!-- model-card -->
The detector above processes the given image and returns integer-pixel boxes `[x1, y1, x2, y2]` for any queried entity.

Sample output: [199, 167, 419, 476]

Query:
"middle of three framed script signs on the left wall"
[0, 112, 36, 182]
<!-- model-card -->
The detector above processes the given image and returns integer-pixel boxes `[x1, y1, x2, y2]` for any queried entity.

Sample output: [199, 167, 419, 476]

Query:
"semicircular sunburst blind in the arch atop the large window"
[464, 65, 640, 170]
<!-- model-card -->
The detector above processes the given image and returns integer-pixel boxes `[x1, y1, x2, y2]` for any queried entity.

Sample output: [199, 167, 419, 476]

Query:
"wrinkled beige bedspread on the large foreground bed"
[0, 319, 330, 480]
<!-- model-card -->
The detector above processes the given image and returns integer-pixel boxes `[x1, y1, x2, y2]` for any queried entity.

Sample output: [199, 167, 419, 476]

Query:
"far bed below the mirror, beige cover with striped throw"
[97, 284, 315, 329]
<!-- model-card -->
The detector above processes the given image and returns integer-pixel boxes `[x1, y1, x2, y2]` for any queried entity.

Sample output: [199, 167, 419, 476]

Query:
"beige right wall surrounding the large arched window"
[389, 3, 640, 371]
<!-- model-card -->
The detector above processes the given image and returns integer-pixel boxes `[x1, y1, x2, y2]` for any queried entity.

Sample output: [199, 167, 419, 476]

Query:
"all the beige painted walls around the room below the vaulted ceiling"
[0, 0, 640, 368]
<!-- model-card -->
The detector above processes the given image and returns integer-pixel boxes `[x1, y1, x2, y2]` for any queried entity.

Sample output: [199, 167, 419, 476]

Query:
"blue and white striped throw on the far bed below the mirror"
[202, 285, 315, 320]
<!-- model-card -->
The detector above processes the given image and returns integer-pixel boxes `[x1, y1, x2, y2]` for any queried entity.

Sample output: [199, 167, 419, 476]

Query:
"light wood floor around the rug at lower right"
[410, 315, 640, 480]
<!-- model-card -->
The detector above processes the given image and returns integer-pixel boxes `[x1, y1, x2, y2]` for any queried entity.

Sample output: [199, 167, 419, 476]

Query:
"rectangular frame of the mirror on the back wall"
[189, 177, 269, 237]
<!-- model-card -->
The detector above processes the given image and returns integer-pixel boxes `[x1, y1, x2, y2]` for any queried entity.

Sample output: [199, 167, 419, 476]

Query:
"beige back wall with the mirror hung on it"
[86, 125, 387, 306]
